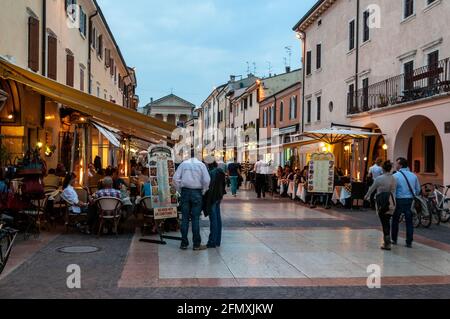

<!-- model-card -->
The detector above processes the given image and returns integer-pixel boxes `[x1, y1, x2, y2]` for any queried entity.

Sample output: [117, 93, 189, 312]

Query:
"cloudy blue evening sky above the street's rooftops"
[98, 0, 316, 106]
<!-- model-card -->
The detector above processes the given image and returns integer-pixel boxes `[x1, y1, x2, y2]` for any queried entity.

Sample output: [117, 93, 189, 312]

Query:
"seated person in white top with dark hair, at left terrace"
[62, 173, 92, 234]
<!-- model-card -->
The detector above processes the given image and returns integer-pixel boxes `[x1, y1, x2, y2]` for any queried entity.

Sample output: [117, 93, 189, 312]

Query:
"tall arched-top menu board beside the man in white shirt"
[148, 145, 178, 219]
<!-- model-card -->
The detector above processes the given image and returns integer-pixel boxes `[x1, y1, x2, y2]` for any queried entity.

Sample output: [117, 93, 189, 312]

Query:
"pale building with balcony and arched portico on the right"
[294, 0, 450, 184]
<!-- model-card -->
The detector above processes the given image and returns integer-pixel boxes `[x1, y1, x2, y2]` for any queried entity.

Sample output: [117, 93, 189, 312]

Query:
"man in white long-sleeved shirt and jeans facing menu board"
[173, 154, 211, 250]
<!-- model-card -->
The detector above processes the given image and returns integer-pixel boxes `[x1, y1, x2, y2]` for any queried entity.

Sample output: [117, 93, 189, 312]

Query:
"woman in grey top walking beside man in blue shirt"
[365, 161, 397, 250]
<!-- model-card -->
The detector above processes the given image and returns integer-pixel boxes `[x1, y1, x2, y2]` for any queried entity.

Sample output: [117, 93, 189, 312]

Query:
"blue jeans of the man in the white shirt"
[181, 188, 203, 247]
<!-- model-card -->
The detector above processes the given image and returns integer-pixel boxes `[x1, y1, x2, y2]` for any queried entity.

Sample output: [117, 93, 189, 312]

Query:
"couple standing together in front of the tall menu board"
[173, 157, 225, 250]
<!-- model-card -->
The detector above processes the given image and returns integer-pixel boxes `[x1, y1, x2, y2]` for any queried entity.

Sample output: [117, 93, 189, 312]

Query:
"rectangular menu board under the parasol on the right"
[308, 153, 335, 194]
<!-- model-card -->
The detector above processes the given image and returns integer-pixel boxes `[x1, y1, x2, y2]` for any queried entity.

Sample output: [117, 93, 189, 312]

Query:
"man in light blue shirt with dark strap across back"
[392, 157, 420, 248]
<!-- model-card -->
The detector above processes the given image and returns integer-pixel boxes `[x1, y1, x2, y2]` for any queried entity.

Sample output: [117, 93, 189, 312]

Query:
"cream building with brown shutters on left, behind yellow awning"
[0, 0, 138, 172]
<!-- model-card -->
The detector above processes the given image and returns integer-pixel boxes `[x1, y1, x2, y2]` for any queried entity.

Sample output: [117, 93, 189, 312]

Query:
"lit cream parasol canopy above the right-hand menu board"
[301, 128, 383, 145]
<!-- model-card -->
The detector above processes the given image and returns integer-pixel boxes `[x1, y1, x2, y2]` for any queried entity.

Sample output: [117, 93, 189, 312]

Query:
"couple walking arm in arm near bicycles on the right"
[366, 158, 420, 250]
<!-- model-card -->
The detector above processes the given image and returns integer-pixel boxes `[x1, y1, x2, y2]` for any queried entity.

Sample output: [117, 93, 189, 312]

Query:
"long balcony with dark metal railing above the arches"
[347, 58, 450, 115]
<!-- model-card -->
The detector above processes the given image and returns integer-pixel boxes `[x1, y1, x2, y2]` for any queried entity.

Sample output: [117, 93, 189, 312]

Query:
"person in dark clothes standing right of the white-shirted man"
[206, 162, 226, 248]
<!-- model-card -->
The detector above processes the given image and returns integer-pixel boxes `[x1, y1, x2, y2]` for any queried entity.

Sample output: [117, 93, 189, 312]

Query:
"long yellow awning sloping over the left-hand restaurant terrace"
[0, 58, 176, 140]
